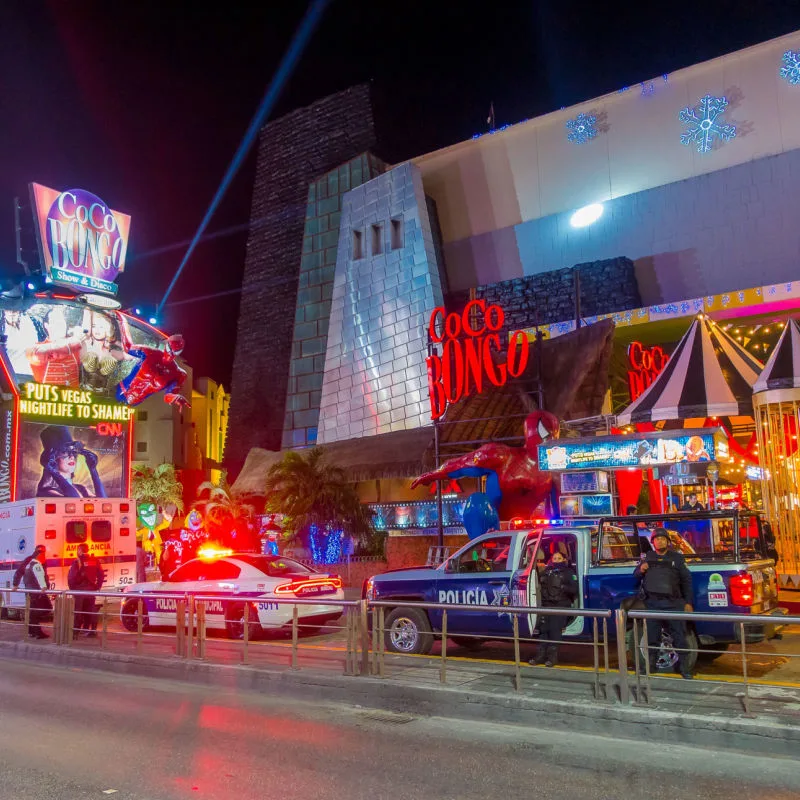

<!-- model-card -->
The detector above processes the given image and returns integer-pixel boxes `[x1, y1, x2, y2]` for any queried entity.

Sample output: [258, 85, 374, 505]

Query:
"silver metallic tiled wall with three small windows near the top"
[318, 164, 442, 444]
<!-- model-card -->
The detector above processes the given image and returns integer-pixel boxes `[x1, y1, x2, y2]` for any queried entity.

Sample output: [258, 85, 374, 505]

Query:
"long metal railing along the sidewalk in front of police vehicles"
[0, 589, 800, 715]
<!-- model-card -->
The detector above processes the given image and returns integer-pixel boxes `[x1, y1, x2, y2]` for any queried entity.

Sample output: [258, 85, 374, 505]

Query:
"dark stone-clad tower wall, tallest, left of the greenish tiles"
[225, 85, 375, 472]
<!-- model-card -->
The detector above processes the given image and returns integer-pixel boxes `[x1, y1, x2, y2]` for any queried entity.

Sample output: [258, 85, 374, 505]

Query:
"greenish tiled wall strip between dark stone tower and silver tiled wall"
[282, 153, 385, 447]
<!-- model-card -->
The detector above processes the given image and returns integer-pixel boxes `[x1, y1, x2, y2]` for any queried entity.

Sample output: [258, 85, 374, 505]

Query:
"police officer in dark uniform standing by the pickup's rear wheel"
[633, 528, 693, 679]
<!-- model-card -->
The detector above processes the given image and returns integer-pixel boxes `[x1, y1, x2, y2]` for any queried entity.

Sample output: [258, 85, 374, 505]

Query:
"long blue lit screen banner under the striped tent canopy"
[539, 428, 729, 471]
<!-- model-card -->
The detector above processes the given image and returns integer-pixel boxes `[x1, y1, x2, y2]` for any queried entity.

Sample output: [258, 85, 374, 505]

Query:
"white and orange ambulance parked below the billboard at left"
[0, 497, 136, 616]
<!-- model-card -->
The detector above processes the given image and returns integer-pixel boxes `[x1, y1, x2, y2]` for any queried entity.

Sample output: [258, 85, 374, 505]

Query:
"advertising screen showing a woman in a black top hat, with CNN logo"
[17, 418, 129, 500]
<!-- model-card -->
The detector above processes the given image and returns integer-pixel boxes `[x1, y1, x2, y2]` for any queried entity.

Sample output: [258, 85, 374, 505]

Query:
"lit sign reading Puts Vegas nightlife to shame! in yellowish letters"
[19, 382, 136, 424]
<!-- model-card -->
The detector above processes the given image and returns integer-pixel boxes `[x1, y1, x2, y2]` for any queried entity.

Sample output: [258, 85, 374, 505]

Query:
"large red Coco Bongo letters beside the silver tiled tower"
[425, 300, 530, 420]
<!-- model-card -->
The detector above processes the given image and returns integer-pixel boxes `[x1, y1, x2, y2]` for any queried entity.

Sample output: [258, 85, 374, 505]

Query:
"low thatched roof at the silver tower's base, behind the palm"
[233, 427, 433, 495]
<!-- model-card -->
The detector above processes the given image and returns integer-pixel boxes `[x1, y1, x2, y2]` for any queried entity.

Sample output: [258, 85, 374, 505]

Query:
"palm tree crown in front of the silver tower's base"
[266, 447, 374, 541]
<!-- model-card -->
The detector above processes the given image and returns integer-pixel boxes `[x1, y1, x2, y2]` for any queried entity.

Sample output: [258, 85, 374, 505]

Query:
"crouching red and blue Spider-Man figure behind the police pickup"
[411, 411, 559, 539]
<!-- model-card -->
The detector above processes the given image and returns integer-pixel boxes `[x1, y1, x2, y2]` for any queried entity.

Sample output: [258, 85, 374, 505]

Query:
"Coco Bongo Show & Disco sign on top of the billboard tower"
[31, 183, 131, 294]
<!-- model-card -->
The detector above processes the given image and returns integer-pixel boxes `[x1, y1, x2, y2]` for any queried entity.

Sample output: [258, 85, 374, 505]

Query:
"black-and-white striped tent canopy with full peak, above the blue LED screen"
[617, 315, 764, 425]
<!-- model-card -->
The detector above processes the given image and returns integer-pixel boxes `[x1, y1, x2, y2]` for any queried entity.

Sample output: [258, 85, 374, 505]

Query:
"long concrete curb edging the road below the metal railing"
[0, 642, 800, 758]
